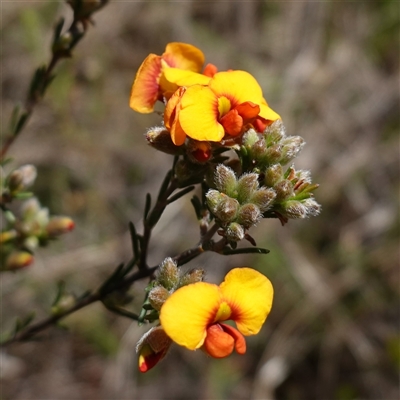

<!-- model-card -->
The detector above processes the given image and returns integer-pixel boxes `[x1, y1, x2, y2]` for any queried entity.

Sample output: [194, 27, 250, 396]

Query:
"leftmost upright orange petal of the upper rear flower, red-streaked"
[129, 54, 161, 114]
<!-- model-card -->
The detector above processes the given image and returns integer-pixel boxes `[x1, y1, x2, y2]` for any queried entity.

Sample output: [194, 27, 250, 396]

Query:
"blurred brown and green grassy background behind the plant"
[1, 0, 400, 400]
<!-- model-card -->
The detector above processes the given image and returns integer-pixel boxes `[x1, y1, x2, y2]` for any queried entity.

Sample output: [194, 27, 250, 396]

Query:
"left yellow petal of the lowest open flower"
[160, 282, 221, 350]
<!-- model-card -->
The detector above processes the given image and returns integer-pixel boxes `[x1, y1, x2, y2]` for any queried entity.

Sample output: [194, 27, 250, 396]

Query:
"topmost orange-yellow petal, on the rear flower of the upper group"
[162, 42, 204, 72]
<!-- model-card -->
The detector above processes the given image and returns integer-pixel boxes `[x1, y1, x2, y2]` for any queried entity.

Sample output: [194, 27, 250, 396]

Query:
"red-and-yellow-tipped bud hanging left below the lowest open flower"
[136, 326, 172, 372]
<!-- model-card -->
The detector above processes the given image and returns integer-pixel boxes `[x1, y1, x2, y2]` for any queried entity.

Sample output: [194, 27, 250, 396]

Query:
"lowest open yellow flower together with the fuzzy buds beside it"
[136, 259, 273, 372]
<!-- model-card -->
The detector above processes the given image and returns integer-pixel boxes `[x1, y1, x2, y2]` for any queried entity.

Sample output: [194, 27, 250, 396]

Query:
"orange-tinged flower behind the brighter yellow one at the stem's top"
[129, 42, 204, 113]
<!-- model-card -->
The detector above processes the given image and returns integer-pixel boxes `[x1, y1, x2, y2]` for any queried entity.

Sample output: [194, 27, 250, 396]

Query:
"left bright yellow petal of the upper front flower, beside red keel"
[179, 85, 224, 142]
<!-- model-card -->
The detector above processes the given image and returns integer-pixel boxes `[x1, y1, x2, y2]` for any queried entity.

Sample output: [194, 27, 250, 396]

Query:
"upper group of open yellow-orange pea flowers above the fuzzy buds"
[130, 43, 280, 162]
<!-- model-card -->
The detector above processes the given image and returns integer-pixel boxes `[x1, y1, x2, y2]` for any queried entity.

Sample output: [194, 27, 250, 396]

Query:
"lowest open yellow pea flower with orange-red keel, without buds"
[160, 267, 273, 358]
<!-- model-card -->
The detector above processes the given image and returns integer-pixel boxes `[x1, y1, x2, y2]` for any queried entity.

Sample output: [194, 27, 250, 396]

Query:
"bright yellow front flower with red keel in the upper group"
[164, 70, 280, 146]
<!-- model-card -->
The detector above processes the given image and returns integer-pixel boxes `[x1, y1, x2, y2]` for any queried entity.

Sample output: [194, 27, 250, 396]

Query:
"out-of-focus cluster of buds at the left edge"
[0, 164, 74, 270]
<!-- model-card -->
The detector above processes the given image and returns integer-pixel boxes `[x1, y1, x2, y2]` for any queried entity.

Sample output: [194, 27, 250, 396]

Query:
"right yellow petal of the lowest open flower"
[220, 268, 273, 336]
